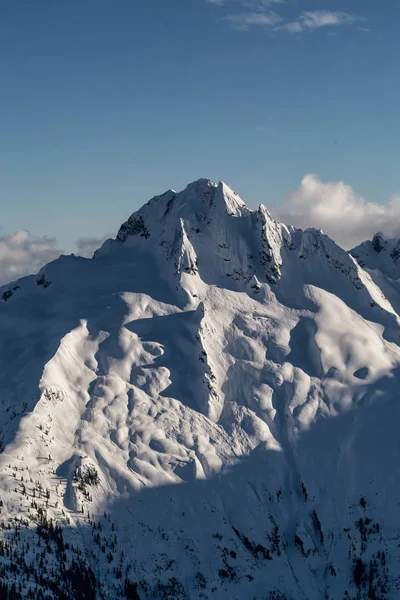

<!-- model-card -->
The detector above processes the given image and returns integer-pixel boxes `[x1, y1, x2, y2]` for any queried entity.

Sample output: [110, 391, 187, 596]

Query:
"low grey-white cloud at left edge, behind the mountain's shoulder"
[0, 230, 60, 284]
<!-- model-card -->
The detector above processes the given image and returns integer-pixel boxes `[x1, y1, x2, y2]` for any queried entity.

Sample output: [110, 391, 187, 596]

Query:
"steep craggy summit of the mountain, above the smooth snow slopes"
[86, 178, 393, 328]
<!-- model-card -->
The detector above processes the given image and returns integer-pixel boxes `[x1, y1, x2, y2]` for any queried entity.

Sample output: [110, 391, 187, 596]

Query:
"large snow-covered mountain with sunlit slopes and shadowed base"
[0, 179, 400, 600]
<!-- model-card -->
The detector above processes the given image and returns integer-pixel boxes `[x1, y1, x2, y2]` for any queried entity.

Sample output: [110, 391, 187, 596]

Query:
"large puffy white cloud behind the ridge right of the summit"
[272, 174, 400, 250]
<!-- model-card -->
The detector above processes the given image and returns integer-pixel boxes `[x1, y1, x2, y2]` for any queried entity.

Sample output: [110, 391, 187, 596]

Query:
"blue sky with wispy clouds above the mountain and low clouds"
[0, 0, 400, 278]
